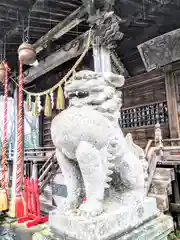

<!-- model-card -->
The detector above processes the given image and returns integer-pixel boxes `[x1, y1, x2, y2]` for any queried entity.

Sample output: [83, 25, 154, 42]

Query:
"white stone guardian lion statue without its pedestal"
[51, 70, 144, 217]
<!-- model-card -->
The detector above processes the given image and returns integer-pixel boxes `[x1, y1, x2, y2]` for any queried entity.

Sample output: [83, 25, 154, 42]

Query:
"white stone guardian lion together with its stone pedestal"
[49, 70, 173, 240]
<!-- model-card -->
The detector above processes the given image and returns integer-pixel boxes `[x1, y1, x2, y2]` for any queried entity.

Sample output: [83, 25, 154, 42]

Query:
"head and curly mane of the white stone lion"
[65, 71, 124, 122]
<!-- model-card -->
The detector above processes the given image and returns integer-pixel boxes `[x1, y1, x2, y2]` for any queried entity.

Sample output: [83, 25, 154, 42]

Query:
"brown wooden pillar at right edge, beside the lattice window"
[165, 72, 180, 138]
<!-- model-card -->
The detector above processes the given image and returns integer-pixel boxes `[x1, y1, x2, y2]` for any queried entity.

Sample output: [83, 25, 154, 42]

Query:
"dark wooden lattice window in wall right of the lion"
[119, 101, 168, 128]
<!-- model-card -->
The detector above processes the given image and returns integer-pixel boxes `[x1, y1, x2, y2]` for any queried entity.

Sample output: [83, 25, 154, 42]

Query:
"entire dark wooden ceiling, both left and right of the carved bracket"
[0, 0, 180, 82]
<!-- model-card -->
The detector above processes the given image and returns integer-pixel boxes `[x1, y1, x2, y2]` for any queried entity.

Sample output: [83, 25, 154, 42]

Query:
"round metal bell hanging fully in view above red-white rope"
[18, 42, 36, 65]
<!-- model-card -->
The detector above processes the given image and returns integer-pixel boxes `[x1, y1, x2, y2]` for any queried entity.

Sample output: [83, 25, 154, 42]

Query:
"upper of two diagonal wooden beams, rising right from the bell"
[34, 7, 86, 53]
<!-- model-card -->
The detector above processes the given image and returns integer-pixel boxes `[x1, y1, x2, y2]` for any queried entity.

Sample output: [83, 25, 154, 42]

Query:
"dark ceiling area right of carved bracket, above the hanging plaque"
[115, 0, 180, 76]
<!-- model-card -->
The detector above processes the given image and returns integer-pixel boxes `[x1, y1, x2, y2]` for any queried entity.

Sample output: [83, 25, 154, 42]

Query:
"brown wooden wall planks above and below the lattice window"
[121, 67, 170, 148]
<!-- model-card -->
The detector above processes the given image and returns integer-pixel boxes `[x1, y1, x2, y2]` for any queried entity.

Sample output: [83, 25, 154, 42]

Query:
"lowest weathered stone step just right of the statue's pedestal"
[148, 193, 169, 212]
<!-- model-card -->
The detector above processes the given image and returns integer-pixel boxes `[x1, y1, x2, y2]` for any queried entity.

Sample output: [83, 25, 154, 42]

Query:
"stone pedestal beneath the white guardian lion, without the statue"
[49, 198, 173, 240]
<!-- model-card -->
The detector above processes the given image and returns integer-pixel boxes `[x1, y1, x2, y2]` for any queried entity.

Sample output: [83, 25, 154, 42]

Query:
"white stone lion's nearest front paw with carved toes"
[78, 200, 103, 217]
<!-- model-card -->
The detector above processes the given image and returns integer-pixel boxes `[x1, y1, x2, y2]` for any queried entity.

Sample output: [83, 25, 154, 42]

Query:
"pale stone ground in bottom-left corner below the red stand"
[0, 215, 54, 240]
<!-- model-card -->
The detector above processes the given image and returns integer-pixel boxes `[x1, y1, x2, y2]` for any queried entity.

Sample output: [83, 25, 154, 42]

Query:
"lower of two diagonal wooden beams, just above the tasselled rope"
[24, 31, 89, 84]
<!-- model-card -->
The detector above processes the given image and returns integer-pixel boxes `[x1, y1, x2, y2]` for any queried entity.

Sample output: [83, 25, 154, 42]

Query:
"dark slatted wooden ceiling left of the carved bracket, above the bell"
[0, 0, 88, 69]
